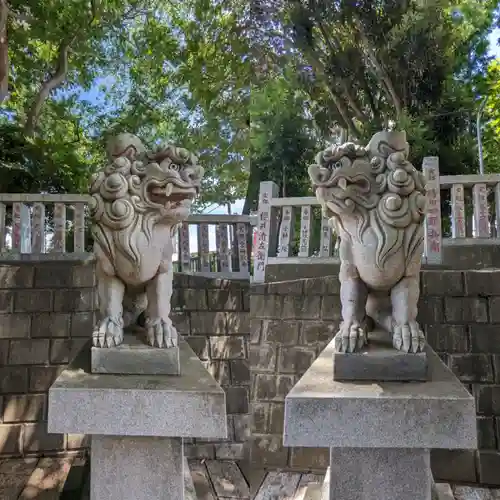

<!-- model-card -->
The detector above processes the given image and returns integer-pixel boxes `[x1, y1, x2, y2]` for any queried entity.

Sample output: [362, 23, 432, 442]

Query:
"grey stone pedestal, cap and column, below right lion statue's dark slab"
[284, 341, 477, 500]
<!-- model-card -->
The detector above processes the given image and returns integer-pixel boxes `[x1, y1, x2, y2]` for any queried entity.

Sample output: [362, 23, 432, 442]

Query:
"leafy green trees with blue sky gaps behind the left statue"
[0, 0, 251, 204]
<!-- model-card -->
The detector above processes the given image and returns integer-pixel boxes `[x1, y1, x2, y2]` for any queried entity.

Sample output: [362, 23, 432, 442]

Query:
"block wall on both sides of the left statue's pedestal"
[0, 260, 250, 459]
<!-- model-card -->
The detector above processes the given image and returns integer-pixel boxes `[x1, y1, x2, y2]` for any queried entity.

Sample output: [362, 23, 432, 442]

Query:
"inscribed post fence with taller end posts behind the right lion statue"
[253, 157, 500, 282]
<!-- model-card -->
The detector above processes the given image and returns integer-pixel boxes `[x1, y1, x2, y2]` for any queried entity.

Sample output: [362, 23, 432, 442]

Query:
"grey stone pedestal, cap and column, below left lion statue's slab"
[48, 342, 227, 500]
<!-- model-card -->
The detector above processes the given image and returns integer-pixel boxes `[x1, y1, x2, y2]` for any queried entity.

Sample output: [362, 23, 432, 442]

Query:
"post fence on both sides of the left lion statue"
[0, 194, 256, 278]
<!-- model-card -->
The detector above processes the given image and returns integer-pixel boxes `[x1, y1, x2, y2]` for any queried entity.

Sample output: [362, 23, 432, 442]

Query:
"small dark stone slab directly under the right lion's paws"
[333, 330, 428, 382]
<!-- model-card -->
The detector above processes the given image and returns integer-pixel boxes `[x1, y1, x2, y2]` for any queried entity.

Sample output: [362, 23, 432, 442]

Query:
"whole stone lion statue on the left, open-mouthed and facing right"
[90, 134, 203, 347]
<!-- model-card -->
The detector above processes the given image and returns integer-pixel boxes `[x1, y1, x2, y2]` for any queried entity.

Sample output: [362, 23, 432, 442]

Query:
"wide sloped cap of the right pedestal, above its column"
[284, 341, 477, 449]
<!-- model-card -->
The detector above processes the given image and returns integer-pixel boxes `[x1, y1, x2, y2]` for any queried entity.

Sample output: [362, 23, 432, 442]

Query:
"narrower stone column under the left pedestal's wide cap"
[90, 436, 186, 500]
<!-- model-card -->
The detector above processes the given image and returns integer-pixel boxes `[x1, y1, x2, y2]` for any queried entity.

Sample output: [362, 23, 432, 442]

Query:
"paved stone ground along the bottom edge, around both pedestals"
[0, 457, 500, 500]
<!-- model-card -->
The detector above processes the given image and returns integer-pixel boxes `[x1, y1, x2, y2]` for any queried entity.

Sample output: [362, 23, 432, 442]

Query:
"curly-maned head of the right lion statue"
[309, 133, 425, 268]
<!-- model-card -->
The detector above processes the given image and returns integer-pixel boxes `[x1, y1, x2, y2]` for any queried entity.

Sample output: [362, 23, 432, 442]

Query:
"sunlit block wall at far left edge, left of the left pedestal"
[0, 262, 94, 456]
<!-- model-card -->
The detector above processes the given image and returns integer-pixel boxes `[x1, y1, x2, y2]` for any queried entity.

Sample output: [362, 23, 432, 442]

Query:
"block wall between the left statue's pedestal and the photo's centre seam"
[178, 274, 250, 460]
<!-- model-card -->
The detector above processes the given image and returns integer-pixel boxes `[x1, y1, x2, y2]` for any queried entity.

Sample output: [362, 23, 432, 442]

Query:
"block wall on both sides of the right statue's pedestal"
[250, 270, 500, 485]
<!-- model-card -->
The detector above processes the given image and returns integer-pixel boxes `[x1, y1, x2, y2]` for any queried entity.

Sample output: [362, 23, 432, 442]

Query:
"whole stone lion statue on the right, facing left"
[309, 132, 426, 352]
